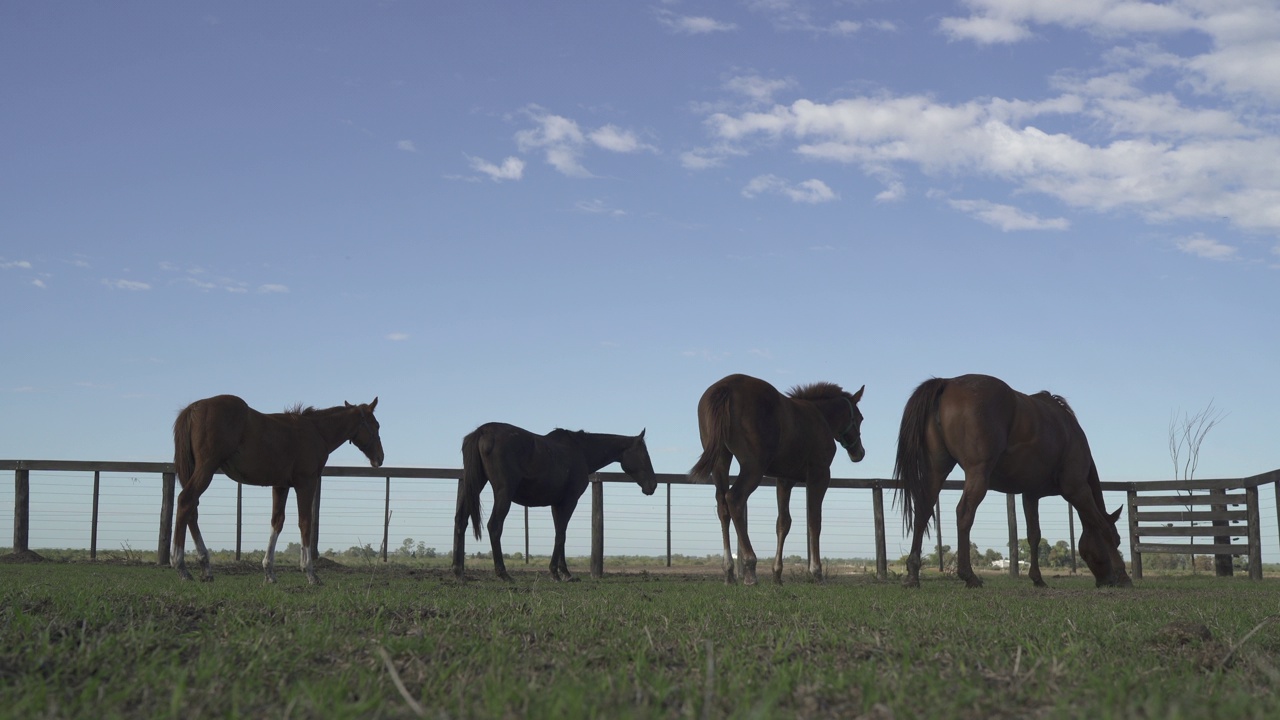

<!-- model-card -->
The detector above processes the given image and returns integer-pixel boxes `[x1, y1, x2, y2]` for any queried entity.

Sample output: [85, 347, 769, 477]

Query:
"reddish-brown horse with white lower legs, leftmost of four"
[172, 395, 383, 584]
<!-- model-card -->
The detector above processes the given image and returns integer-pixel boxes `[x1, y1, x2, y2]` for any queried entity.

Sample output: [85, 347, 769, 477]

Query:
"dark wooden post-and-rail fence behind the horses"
[0, 460, 1280, 579]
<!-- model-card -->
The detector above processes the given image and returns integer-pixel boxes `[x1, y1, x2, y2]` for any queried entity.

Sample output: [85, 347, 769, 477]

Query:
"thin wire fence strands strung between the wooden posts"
[10, 470, 1280, 564]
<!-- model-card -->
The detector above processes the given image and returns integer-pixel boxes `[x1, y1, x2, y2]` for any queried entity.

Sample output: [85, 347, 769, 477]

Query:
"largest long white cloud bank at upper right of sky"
[707, 94, 1280, 232]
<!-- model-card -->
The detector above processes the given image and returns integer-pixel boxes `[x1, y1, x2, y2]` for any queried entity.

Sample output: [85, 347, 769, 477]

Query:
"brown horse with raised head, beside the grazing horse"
[689, 375, 867, 585]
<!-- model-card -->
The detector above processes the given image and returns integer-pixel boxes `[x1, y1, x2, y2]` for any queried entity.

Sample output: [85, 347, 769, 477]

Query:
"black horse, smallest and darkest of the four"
[453, 423, 658, 580]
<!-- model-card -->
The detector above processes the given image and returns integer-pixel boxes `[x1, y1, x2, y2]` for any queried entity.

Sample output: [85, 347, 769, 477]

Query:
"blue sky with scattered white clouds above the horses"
[0, 0, 1280, 552]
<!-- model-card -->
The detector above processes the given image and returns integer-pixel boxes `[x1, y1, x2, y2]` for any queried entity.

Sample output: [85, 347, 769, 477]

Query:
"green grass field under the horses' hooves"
[0, 560, 1280, 719]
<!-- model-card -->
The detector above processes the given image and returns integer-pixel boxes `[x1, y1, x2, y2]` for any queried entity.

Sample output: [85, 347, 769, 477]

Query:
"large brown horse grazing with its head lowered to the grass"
[893, 375, 1133, 588]
